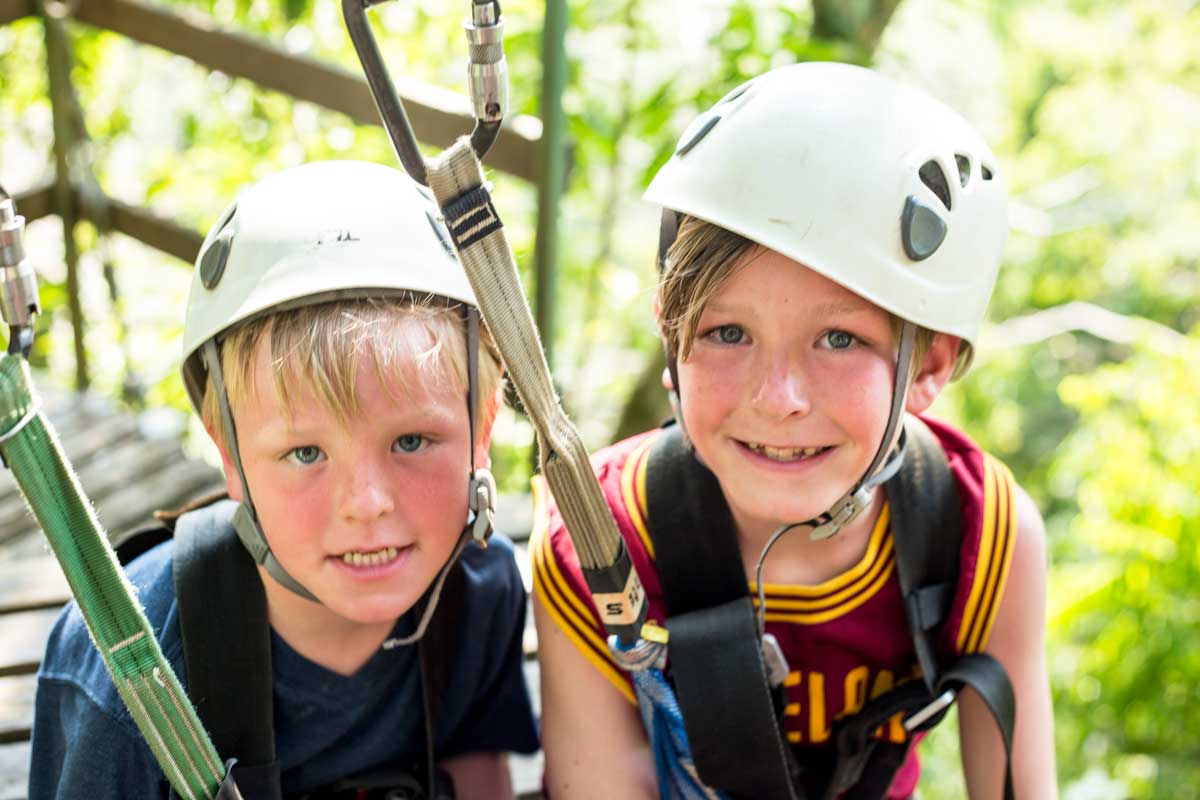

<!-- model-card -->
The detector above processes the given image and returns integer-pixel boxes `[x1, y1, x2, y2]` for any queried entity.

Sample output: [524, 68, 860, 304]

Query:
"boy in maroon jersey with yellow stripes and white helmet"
[532, 64, 1055, 798]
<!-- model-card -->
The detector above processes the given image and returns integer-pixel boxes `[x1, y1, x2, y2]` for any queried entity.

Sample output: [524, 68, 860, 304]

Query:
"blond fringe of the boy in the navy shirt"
[200, 295, 502, 441]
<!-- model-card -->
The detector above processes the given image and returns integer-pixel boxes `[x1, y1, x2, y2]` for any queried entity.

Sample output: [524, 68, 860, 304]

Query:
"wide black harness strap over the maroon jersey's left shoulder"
[646, 426, 798, 799]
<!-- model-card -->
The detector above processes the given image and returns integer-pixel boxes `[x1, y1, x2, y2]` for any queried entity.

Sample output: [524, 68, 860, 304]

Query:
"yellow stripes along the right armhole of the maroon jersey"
[958, 455, 1016, 654]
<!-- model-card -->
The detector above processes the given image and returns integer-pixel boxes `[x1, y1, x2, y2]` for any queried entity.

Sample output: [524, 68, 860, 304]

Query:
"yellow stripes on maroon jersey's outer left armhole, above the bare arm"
[529, 480, 637, 705]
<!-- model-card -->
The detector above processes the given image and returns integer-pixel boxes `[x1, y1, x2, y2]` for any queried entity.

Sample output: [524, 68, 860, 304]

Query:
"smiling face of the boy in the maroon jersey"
[678, 247, 895, 530]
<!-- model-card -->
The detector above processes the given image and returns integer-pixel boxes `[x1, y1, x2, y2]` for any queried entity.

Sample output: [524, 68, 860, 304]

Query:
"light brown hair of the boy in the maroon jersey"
[659, 216, 971, 381]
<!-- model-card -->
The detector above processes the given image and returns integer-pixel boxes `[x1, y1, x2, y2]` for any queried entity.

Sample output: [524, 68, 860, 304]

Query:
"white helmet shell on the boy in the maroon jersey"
[646, 62, 1008, 344]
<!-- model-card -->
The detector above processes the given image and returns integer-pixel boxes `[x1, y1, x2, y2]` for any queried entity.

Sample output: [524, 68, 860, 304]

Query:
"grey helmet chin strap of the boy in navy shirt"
[202, 306, 496, 650]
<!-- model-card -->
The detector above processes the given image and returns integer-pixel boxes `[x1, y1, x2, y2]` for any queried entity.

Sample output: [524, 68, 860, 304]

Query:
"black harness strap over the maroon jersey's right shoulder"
[884, 415, 962, 691]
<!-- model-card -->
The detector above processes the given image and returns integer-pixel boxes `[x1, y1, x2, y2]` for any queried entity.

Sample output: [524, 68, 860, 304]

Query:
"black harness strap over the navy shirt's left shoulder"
[174, 500, 281, 800]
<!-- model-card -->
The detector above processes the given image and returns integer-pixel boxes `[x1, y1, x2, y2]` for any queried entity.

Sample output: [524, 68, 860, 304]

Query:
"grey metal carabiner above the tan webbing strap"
[342, 0, 509, 186]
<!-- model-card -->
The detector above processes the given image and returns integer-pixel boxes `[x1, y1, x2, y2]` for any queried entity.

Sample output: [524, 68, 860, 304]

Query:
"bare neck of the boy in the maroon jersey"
[733, 488, 884, 587]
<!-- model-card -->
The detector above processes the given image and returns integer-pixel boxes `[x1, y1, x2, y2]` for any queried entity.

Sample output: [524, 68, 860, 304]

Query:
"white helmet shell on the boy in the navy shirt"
[184, 161, 478, 409]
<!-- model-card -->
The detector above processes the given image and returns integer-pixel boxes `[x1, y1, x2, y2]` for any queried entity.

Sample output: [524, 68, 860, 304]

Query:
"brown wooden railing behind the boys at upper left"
[0, 0, 549, 389]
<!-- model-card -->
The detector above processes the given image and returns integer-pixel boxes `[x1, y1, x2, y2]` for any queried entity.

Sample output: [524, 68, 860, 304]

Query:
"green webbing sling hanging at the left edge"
[0, 354, 228, 800]
